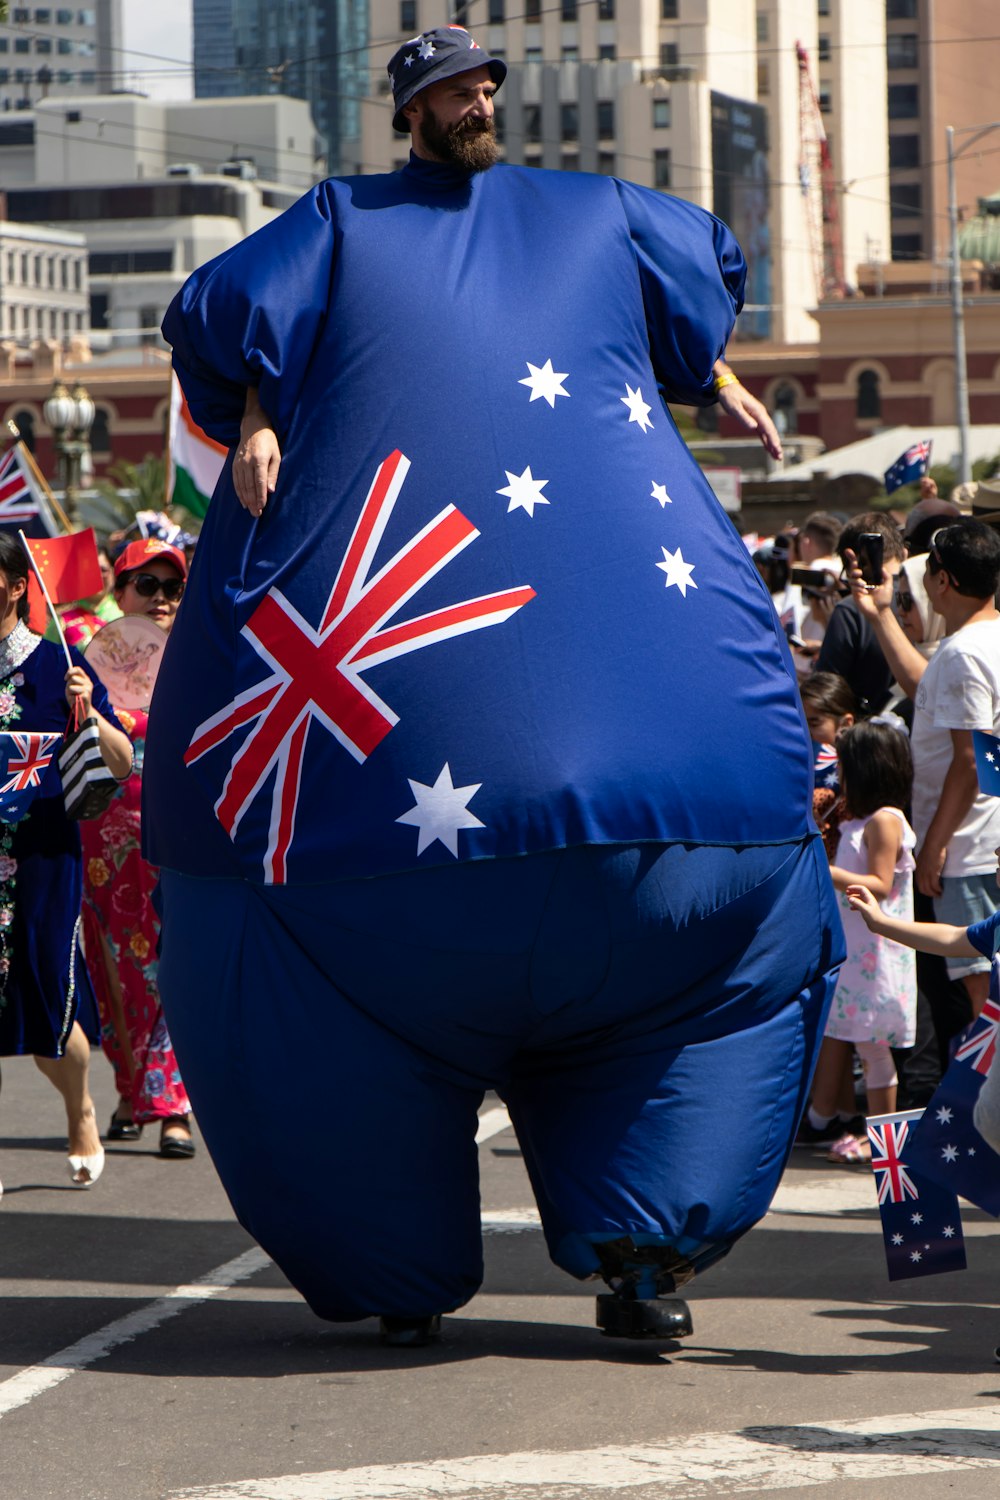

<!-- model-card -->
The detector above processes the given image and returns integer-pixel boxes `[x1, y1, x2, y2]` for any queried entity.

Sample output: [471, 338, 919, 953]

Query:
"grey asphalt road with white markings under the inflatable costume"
[0, 1058, 1000, 1500]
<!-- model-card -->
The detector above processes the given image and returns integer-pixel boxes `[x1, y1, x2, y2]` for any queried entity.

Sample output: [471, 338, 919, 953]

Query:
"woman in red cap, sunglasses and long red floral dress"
[84, 537, 195, 1158]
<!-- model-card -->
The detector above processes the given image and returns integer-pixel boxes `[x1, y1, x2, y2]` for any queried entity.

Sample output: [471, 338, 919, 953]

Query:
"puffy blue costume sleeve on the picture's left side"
[163, 185, 337, 447]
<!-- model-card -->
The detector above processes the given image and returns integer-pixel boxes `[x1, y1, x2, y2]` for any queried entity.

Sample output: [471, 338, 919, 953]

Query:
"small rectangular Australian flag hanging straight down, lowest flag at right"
[868, 1110, 966, 1281]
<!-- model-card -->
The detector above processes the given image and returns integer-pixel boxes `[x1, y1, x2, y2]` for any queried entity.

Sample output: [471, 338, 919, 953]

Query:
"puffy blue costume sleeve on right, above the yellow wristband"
[615, 179, 747, 407]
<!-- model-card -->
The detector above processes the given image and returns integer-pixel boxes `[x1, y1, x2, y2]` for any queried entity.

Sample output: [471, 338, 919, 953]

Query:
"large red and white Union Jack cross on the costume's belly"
[184, 450, 535, 885]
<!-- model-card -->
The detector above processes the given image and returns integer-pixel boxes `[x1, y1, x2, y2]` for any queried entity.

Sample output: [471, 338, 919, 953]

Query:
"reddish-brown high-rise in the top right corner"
[886, 0, 1000, 261]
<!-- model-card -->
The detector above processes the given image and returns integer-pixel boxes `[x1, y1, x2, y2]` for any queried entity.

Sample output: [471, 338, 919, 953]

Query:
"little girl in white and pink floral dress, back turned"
[804, 720, 916, 1164]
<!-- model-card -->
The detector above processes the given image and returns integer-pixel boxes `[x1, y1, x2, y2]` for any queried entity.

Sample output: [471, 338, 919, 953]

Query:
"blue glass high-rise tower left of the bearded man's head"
[193, 0, 369, 173]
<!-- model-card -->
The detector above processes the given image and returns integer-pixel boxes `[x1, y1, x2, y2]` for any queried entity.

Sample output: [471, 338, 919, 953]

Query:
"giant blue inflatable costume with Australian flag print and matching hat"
[144, 29, 841, 1340]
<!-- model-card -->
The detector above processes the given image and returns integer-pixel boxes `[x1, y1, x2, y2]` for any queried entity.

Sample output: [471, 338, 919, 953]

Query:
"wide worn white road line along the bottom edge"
[169, 1406, 1000, 1500]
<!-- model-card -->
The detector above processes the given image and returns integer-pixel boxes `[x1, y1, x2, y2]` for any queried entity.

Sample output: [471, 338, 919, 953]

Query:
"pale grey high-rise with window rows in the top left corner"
[0, 0, 121, 114]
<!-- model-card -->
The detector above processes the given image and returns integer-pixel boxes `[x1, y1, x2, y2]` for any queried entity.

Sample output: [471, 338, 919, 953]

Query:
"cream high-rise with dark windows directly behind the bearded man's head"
[361, 0, 889, 344]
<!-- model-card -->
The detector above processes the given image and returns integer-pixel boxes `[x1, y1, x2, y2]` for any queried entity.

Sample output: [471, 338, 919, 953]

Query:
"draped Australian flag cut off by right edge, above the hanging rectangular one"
[909, 1001, 1000, 1218]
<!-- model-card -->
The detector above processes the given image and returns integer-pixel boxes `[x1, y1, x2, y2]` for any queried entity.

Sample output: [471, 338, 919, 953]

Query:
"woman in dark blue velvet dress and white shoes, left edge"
[0, 533, 132, 1188]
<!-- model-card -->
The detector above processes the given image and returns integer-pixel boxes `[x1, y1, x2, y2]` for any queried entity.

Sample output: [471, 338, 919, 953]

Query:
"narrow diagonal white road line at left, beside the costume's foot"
[0, 1247, 271, 1418]
